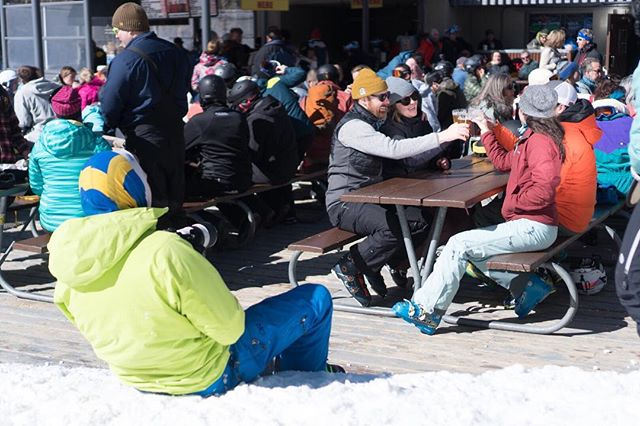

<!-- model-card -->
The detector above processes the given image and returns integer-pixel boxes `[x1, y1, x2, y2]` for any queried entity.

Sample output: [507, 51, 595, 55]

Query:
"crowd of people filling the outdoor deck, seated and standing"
[0, 3, 640, 402]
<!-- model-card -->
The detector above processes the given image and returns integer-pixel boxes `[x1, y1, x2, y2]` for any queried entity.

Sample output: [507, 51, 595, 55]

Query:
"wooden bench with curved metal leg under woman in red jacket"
[443, 202, 625, 334]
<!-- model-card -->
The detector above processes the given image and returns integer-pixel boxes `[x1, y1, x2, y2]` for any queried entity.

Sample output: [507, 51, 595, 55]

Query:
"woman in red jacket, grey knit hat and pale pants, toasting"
[393, 85, 564, 334]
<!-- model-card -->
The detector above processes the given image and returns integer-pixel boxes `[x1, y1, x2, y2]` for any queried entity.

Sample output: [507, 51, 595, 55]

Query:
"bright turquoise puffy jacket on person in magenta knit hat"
[29, 118, 111, 232]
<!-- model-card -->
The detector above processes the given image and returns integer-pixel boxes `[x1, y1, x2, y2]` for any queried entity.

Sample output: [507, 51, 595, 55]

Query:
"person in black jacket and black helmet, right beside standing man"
[184, 75, 251, 198]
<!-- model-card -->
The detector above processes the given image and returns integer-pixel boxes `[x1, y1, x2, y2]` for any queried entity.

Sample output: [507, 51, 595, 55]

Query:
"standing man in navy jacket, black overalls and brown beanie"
[100, 2, 191, 223]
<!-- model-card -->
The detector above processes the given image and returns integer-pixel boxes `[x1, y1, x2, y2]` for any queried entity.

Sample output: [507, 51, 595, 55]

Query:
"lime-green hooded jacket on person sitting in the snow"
[49, 208, 244, 395]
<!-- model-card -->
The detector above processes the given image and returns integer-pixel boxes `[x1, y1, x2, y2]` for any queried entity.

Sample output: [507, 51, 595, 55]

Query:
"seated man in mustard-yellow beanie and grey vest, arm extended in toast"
[326, 69, 469, 306]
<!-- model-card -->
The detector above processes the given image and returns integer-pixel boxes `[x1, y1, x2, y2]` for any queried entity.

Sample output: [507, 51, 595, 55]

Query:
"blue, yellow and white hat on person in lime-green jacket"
[80, 150, 151, 216]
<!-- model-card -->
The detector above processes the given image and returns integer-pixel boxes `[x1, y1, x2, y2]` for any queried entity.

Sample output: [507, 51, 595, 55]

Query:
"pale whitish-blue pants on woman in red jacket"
[413, 219, 558, 315]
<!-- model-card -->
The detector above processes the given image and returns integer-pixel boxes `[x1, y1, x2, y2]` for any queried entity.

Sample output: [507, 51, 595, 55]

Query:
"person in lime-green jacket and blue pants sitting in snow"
[49, 152, 336, 396]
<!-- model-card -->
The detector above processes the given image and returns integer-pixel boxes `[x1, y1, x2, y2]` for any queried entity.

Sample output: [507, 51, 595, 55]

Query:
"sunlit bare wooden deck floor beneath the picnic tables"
[0, 205, 640, 373]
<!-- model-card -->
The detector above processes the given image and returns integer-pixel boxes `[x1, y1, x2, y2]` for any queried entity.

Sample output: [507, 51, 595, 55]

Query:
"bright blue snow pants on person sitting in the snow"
[196, 284, 333, 397]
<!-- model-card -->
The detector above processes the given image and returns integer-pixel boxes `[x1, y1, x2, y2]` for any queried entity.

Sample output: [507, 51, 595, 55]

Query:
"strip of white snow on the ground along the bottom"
[0, 364, 640, 426]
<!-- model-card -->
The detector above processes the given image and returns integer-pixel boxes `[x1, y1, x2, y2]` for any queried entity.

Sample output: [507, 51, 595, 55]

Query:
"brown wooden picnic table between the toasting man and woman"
[340, 156, 509, 298]
